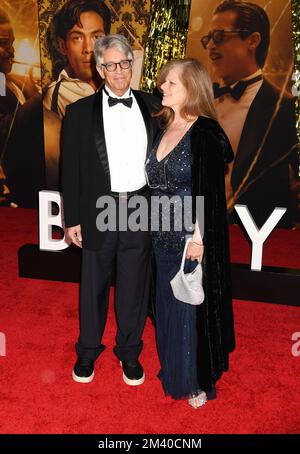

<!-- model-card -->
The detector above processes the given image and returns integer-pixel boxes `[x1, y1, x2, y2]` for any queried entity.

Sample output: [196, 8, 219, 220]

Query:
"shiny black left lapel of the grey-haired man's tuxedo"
[93, 90, 111, 185]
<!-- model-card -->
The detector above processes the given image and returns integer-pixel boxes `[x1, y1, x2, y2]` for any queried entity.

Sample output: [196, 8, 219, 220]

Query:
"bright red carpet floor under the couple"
[0, 208, 300, 434]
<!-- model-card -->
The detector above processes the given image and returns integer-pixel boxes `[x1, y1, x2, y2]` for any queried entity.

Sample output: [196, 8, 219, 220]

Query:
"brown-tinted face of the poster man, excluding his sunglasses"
[207, 11, 255, 83]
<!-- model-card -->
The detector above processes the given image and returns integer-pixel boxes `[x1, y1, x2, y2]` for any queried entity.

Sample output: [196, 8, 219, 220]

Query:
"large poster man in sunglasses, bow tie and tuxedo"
[201, 0, 299, 227]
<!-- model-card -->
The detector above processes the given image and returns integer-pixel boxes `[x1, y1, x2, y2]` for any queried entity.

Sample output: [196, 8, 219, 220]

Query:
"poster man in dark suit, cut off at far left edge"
[0, 8, 42, 206]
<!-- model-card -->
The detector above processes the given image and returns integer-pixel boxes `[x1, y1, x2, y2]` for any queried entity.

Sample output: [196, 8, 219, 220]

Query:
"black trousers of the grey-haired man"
[76, 219, 151, 361]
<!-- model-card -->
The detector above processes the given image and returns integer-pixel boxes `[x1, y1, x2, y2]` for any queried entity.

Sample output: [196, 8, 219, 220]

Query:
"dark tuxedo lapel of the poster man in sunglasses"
[231, 80, 274, 190]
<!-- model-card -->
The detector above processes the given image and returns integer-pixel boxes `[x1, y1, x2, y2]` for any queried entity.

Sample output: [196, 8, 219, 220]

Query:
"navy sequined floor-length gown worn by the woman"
[146, 129, 199, 399]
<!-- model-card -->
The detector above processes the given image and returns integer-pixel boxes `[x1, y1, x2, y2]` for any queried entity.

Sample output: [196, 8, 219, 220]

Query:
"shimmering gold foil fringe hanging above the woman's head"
[141, 0, 191, 92]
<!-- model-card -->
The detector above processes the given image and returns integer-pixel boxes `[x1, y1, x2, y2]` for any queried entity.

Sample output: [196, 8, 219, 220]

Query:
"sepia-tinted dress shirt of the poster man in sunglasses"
[215, 69, 263, 200]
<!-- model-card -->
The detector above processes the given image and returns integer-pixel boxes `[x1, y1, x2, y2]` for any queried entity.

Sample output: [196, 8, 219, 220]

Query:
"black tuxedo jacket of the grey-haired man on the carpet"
[62, 90, 158, 250]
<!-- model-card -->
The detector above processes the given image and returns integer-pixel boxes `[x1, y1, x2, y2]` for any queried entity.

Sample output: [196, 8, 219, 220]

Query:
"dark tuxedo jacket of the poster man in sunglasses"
[231, 80, 299, 227]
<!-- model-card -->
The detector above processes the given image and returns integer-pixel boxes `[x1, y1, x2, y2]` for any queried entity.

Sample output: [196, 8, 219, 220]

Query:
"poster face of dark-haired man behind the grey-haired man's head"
[59, 11, 105, 82]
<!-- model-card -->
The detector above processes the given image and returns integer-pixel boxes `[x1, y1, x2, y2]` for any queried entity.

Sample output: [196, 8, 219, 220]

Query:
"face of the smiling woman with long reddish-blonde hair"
[160, 68, 187, 110]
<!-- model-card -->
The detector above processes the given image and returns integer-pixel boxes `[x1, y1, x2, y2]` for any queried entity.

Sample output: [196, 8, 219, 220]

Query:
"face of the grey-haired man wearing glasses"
[98, 47, 132, 96]
